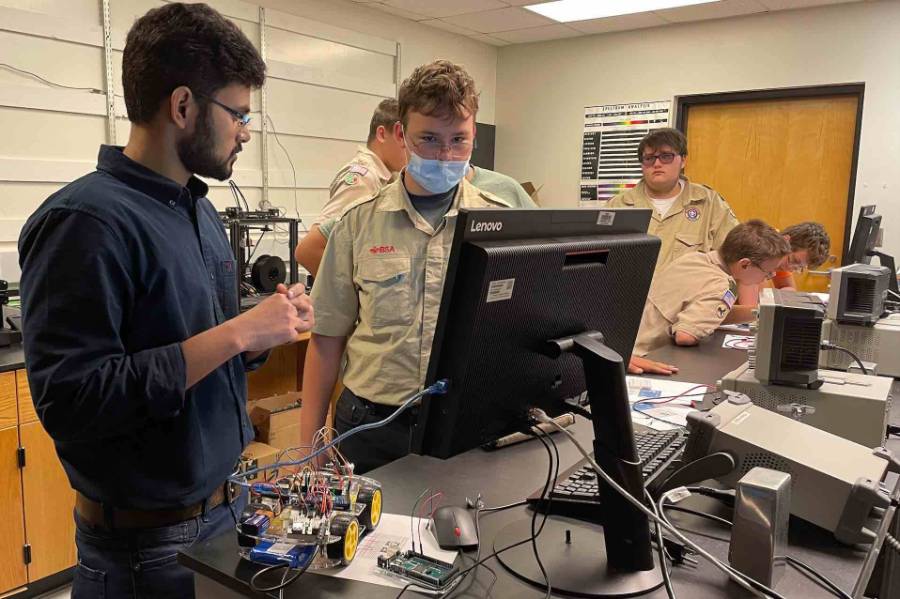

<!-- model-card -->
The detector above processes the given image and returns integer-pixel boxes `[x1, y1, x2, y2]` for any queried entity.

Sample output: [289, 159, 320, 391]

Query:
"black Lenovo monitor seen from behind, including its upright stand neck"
[413, 209, 660, 590]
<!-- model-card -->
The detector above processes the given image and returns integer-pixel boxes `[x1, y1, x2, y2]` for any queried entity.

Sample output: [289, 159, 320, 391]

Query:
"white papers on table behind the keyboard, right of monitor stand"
[627, 376, 707, 431]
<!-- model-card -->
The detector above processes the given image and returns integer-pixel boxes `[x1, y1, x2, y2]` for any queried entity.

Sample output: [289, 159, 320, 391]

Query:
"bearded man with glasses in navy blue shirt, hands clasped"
[19, 4, 313, 598]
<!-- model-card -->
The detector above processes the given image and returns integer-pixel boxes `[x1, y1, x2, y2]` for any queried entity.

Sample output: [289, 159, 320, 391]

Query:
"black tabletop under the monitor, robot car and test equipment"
[179, 333, 900, 599]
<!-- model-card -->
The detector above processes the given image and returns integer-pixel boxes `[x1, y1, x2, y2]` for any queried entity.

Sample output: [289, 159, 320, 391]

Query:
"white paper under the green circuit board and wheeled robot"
[310, 514, 456, 592]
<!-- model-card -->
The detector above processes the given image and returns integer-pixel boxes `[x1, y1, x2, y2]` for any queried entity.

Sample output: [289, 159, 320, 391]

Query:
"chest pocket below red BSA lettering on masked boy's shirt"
[357, 254, 413, 327]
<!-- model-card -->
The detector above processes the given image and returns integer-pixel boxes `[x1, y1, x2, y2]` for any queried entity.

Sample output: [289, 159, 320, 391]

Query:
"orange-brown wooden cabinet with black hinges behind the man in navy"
[0, 370, 75, 595]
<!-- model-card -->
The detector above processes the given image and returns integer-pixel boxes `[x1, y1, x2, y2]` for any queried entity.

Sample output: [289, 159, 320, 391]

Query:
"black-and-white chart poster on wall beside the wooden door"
[579, 100, 672, 207]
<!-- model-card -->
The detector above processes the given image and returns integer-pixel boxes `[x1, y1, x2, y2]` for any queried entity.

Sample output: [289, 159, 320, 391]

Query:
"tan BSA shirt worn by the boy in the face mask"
[312, 177, 510, 405]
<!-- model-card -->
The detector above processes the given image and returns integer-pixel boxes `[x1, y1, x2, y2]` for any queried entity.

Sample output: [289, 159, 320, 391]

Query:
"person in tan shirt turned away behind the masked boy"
[294, 98, 406, 276]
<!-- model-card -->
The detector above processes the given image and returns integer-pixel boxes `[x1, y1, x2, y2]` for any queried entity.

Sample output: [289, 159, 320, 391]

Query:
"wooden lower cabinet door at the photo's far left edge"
[0, 426, 28, 595]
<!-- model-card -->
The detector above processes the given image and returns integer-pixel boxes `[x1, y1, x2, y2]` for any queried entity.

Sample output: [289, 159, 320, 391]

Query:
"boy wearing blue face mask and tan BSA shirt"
[301, 60, 513, 473]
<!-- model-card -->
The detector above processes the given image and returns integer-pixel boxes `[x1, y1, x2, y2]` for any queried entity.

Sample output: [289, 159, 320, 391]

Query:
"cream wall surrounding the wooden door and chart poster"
[496, 1, 900, 256]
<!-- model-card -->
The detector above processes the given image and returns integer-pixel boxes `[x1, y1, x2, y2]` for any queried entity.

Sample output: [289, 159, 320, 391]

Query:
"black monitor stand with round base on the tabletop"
[494, 331, 665, 597]
